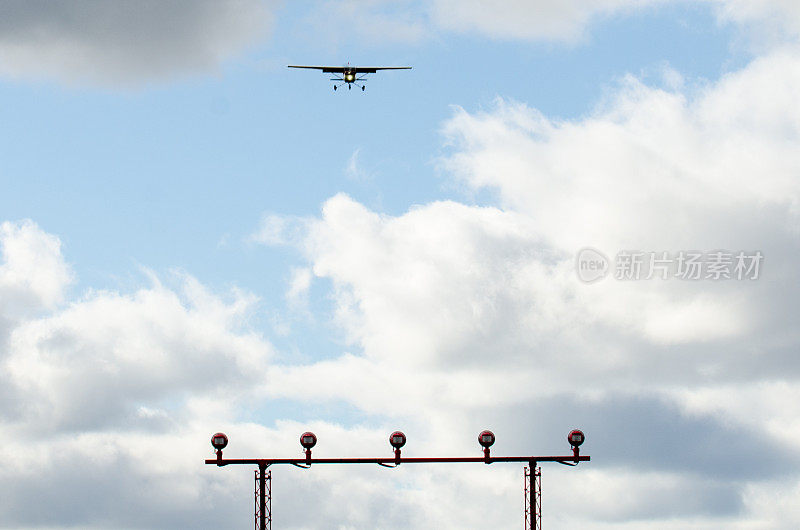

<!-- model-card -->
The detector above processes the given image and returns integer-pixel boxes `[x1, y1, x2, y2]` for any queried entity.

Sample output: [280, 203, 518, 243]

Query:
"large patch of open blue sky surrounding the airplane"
[2, 2, 748, 292]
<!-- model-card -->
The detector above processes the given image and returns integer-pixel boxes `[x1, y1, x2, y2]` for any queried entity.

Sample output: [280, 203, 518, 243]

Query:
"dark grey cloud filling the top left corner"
[0, 0, 274, 85]
